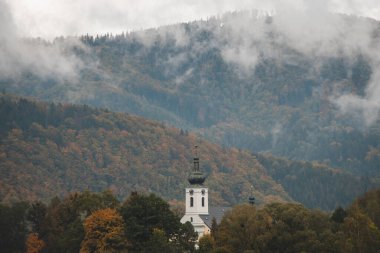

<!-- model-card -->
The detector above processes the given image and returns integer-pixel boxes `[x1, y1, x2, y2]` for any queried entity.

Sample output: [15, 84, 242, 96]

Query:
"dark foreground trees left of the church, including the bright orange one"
[0, 191, 197, 253]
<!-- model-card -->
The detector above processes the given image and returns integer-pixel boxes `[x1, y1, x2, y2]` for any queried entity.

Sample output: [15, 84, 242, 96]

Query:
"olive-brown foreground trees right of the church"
[199, 190, 380, 253]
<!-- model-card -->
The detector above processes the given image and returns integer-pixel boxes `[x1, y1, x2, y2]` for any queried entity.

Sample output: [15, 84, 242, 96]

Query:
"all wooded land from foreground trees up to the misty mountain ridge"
[0, 6, 380, 253]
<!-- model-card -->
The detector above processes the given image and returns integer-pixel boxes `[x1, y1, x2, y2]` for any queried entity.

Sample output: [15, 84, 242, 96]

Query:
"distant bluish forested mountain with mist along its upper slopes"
[0, 12, 380, 181]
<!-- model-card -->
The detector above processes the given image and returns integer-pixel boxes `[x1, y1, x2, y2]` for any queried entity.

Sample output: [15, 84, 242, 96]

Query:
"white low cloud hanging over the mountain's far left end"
[0, 1, 83, 81]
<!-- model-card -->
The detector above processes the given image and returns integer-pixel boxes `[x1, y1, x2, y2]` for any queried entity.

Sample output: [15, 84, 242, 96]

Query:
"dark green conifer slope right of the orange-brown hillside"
[256, 154, 380, 210]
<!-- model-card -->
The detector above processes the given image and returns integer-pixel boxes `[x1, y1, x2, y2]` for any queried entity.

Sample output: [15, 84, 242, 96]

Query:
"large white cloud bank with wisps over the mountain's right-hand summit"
[126, 0, 380, 126]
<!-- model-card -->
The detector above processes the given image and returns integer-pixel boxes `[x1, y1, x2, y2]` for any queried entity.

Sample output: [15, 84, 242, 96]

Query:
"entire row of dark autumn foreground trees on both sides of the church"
[0, 190, 380, 253]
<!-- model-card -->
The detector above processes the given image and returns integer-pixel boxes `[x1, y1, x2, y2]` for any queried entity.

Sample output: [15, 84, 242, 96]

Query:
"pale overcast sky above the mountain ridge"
[4, 0, 380, 39]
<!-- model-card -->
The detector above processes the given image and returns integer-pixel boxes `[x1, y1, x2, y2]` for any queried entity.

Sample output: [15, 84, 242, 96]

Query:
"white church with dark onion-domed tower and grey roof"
[181, 146, 230, 238]
